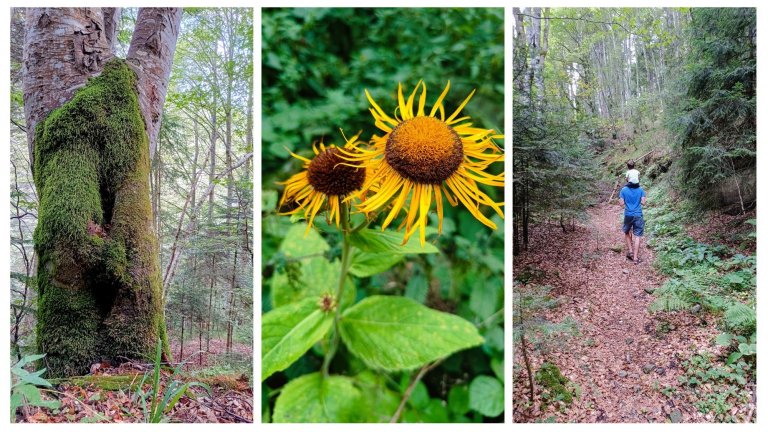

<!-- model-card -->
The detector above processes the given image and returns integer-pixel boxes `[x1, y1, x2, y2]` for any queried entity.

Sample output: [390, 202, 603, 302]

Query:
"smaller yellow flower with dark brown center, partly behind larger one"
[278, 134, 365, 232]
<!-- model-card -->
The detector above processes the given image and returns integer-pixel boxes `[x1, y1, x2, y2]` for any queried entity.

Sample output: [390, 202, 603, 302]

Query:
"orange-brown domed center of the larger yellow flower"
[384, 117, 464, 184]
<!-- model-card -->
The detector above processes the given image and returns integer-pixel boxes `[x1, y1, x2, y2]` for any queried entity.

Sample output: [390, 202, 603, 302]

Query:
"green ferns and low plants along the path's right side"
[645, 183, 757, 421]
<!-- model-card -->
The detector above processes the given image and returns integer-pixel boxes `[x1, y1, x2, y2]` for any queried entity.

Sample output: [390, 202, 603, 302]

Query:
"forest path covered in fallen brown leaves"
[515, 204, 716, 422]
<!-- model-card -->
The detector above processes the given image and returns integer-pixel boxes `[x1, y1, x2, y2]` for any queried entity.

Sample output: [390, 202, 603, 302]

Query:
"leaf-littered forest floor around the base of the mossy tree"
[16, 339, 253, 423]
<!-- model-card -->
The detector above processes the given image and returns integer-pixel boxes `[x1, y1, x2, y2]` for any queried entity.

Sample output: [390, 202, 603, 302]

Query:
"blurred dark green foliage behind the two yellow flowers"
[261, 8, 504, 422]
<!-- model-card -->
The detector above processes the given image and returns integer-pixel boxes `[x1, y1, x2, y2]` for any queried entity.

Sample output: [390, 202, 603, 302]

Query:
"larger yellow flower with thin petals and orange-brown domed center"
[343, 81, 504, 245]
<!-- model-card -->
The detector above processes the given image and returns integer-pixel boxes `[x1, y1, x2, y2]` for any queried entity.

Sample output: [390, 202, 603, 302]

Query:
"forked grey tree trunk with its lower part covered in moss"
[24, 8, 181, 377]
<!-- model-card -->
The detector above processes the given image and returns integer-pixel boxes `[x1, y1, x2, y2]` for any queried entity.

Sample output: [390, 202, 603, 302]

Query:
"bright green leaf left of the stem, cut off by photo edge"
[261, 299, 333, 381]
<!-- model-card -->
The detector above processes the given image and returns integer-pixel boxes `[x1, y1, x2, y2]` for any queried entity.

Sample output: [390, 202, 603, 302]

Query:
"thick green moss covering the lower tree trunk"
[35, 59, 167, 376]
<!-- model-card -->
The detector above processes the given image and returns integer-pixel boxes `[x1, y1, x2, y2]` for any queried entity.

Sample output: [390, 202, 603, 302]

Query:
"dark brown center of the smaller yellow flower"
[307, 147, 365, 195]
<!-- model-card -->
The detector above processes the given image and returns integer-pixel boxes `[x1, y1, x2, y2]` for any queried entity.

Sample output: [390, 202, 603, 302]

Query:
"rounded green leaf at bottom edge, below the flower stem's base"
[272, 372, 362, 423]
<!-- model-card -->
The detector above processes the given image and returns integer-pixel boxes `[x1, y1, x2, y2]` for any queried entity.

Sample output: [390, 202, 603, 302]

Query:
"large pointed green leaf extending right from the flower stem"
[340, 296, 483, 370]
